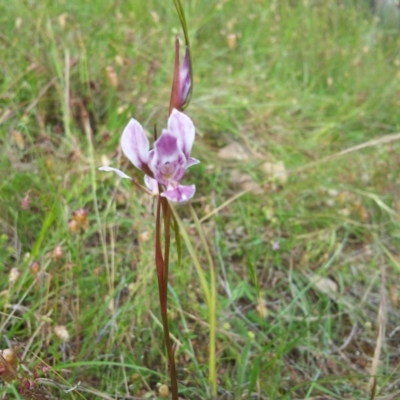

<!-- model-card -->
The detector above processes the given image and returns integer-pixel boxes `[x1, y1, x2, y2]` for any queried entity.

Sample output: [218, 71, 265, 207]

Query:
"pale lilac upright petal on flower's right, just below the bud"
[168, 109, 195, 158]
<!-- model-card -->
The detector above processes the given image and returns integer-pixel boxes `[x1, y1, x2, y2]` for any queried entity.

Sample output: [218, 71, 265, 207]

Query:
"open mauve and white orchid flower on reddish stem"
[99, 109, 199, 203]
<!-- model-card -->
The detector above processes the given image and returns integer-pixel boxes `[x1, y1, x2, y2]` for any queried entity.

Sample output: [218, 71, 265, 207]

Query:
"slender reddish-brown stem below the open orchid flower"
[155, 196, 178, 400]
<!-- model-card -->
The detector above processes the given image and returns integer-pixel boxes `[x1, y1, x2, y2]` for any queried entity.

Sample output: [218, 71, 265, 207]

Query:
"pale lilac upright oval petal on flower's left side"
[121, 118, 149, 171]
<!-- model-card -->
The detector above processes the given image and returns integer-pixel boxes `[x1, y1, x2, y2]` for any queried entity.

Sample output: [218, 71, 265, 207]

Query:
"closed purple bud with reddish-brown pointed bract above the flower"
[169, 37, 192, 114]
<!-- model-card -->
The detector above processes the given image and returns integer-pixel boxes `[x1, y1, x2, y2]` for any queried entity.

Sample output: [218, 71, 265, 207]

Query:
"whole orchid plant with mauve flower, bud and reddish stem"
[99, 0, 206, 400]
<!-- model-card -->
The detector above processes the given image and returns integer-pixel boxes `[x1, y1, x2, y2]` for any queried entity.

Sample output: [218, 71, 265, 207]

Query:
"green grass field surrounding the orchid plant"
[0, 0, 400, 399]
